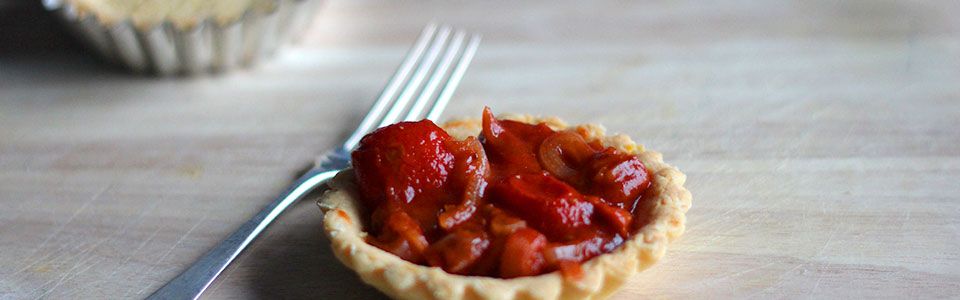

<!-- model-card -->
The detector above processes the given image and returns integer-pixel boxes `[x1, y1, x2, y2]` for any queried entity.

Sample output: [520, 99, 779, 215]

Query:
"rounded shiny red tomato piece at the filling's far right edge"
[589, 148, 650, 211]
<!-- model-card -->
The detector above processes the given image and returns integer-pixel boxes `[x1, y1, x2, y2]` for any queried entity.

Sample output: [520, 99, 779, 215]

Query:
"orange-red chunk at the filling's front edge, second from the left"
[424, 229, 490, 274]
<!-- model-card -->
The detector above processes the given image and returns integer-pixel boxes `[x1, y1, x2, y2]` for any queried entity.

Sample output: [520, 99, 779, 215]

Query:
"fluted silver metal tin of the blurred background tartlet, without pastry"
[43, 0, 322, 76]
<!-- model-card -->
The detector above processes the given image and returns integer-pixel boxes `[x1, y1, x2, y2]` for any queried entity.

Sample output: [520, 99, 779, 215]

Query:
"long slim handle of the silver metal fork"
[147, 168, 340, 299]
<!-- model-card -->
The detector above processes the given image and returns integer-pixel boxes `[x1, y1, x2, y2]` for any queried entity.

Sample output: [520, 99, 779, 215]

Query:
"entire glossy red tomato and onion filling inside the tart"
[352, 109, 650, 278]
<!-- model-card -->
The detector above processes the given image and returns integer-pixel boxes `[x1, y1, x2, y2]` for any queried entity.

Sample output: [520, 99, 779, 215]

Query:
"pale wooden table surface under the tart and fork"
[0, 0, 960, 299]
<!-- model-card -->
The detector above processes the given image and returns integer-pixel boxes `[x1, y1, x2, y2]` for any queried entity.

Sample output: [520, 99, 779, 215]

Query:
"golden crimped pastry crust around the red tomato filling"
[318, 115, 691, 299]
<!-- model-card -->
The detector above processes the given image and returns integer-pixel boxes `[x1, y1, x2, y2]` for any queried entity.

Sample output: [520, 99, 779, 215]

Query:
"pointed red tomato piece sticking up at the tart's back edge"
[480, 107, 554, 174]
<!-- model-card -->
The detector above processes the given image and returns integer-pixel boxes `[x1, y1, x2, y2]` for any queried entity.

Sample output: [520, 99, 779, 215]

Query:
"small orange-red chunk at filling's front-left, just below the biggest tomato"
[368, 208, 430, 262]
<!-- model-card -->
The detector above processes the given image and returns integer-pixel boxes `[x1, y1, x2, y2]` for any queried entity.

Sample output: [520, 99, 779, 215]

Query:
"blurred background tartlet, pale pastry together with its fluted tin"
[43, 0, 322, 75]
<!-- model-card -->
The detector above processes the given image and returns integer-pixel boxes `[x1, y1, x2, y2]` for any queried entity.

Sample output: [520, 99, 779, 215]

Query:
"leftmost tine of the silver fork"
[343, 23, 437, 151]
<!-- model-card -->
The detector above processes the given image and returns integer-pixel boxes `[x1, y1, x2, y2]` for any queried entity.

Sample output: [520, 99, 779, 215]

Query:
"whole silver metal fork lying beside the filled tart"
[147, 24, 480, 299]
